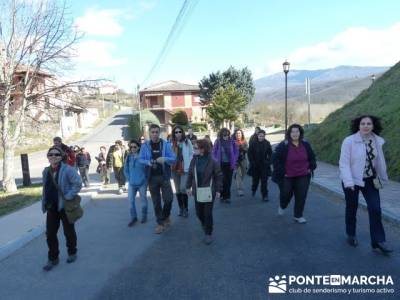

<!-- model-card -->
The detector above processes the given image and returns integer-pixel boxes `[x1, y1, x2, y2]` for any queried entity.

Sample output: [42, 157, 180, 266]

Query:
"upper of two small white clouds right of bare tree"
[75, 8, 129, 36]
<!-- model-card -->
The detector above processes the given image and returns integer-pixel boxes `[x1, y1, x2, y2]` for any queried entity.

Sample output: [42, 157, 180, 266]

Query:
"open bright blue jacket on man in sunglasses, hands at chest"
[139, 139, 176, 180]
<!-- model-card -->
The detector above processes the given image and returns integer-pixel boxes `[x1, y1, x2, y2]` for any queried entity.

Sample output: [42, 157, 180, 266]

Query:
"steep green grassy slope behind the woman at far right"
[307, 62, 400, 181]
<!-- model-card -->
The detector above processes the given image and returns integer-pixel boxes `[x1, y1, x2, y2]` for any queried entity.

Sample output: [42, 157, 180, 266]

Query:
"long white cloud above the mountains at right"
[264, 23, 400, 73]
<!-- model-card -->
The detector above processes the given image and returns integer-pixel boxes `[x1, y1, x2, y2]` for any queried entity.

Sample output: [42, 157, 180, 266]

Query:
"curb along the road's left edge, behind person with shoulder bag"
[0, 190, 98, 261]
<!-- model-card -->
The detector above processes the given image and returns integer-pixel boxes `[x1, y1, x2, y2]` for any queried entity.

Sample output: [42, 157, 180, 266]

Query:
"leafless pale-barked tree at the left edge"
[0, 0, 94, 191]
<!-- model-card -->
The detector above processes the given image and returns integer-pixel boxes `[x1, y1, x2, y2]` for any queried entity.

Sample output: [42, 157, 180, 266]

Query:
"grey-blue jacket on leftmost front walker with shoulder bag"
[42, 162, 82, 213]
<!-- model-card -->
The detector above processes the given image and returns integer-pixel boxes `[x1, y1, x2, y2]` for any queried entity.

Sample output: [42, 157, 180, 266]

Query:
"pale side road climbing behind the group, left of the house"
[0, 109, 132, 185]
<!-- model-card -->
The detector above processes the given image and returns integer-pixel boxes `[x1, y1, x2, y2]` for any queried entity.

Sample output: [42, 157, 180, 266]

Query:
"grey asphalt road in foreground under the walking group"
[0, 179, 400, 300]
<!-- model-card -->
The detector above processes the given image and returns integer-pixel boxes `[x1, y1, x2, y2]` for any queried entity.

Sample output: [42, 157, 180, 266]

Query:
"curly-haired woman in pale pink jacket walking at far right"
[339, 115, 392, 254]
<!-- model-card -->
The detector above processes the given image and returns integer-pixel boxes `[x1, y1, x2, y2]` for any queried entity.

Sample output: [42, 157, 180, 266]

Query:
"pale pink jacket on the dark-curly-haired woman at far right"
[339, 132, 388, 187]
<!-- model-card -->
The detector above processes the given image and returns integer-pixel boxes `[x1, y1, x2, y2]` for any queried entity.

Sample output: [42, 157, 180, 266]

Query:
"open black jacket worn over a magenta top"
[272, 140, 317, 183]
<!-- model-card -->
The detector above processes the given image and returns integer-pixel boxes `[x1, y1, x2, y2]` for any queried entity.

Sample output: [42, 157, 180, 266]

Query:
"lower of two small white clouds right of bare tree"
[77, 40, 127, 68]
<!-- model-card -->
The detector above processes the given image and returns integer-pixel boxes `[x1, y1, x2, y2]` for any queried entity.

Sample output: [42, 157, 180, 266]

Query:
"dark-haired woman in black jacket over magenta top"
[272, 124, 317, 224]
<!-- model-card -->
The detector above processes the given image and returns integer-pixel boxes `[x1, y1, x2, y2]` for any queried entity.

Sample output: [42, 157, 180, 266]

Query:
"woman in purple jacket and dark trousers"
[212, 128, 239, 203]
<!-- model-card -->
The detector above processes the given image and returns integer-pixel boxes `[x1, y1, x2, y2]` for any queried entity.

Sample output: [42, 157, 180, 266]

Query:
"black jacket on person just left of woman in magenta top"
[247, 140, 272, 176]
